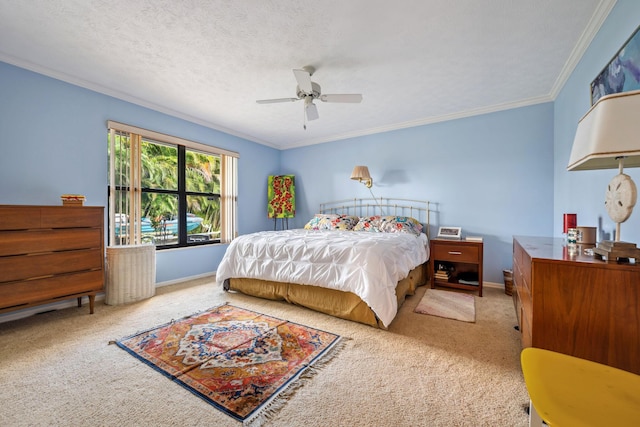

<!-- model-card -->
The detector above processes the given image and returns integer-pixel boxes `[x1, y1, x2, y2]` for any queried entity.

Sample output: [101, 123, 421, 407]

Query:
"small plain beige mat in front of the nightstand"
[414, 289, 476, 323]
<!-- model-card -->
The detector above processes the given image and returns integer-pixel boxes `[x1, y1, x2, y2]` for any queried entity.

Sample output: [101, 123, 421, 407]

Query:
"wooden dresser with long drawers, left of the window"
[0, 205, 104, 313]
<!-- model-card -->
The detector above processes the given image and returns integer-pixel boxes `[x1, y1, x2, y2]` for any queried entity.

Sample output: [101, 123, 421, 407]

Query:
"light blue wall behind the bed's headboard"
[281, 103, 553, 283]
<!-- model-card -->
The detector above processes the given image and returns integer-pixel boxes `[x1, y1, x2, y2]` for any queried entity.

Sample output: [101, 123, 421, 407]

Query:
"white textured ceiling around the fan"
[0, 0, 615, 149]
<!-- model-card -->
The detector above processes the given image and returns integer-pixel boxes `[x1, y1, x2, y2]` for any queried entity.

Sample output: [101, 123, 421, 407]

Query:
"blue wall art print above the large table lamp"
[591, 27, 640, 105]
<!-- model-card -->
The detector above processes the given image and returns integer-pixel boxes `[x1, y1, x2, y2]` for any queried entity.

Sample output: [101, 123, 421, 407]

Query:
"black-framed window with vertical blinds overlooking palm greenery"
[108, 121, 238, 249]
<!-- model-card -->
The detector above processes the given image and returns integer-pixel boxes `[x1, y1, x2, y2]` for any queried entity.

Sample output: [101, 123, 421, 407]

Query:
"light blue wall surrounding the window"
[0, 62, 280, 282]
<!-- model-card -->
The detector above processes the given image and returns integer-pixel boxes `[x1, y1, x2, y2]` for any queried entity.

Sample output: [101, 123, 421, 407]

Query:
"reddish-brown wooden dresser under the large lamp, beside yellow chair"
[513, 236, 640, 374]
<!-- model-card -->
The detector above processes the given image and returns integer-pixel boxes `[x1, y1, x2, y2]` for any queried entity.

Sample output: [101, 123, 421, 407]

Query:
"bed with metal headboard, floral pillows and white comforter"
[216, 199, 430, 329]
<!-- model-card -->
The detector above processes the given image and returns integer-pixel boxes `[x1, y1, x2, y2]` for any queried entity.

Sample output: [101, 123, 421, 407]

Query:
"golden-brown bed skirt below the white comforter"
[224, 263, 428, 329]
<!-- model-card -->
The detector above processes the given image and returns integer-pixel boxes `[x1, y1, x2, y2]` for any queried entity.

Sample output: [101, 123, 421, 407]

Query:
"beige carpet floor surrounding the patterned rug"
[0, 278, 528, 427]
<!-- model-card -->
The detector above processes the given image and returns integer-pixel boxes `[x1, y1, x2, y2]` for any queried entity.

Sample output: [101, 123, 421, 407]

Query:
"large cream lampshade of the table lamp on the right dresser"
[567, 90, 640, 171]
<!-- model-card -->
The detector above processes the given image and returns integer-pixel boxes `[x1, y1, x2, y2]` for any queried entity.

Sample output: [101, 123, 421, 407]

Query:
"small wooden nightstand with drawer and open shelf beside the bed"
[430, 239, 483, 296]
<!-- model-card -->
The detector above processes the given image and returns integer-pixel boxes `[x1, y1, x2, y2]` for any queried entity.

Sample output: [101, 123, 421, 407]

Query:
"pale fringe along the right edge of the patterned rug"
[242, 337, 349, 427]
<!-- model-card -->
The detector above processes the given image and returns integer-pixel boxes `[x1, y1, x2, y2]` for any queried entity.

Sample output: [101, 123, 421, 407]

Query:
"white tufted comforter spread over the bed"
[216, 229, 428, 327]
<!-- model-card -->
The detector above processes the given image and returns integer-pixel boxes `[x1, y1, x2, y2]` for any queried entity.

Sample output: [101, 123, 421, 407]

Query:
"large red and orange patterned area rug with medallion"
[116, 304, 340, 425]
